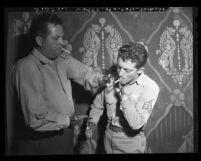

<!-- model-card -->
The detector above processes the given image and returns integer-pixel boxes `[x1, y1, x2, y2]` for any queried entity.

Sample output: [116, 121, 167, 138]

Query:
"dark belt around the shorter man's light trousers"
[109, 124, 144, 137]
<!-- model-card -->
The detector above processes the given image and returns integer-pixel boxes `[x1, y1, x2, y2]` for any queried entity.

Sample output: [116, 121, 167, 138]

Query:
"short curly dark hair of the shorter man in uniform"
[117, 42, 148, 69]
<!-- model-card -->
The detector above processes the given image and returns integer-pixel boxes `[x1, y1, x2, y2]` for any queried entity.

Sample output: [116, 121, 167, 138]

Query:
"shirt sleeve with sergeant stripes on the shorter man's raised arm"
[121, 85, 159, 129]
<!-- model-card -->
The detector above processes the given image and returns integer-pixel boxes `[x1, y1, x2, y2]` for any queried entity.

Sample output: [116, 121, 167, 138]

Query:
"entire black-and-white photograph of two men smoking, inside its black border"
[4, 6, 198, 156]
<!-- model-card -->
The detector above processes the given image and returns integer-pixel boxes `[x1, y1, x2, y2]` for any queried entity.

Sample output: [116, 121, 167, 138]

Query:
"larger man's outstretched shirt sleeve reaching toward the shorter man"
[66, 56, 102, 90]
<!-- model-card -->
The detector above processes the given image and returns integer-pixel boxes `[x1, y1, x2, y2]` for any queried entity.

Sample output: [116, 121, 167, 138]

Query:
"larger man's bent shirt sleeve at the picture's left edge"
[12, 61, 70, 131]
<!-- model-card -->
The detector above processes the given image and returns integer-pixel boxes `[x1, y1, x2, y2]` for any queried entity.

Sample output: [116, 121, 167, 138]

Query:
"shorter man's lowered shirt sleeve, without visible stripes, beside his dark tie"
[89, 92, 104, 124]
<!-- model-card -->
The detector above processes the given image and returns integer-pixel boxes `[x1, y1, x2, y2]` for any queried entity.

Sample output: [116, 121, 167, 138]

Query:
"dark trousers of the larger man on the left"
[13, 128, 74, 155]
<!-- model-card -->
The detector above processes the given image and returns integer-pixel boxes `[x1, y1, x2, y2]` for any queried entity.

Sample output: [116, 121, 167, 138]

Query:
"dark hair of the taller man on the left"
[29, 12, 62, 46]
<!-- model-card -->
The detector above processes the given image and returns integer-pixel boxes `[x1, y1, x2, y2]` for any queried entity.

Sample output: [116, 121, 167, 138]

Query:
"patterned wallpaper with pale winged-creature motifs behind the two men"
[7, 7, 194, 153]
